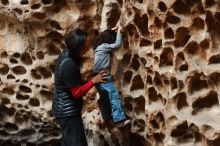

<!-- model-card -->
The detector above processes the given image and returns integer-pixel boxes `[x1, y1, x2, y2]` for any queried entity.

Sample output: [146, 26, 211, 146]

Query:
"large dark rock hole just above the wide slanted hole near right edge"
[188, 73, 208, 94]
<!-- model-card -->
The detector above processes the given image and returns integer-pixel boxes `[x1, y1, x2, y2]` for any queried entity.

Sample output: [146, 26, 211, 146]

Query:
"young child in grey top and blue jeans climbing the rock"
[93, 26, 130, 127]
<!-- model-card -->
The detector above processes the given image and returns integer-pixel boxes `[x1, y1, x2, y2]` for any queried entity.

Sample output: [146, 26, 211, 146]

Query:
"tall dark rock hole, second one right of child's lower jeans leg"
[134, 96, 145, 114]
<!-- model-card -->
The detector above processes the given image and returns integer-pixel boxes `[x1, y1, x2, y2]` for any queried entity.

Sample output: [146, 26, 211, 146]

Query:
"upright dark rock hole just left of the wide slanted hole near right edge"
[174, 92, 188, 110]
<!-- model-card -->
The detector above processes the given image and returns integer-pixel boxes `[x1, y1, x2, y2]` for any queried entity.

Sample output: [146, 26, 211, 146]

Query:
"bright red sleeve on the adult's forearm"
[70, 81, 94, 98]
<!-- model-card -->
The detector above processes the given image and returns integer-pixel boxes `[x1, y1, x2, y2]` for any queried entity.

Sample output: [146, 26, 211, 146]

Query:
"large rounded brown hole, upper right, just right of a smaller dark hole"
[174, 27, 191, 47]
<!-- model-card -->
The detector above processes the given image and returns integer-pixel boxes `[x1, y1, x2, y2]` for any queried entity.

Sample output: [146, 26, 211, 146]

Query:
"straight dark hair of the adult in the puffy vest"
[65, 29, 88, 55]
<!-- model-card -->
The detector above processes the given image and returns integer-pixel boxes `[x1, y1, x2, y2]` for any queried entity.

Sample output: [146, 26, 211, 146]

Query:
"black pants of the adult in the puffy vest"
[57, 115, 87, 146]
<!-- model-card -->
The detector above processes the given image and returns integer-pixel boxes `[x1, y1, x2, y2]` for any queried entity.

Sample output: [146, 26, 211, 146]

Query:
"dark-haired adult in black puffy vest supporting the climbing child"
[52, 29, 107, 146]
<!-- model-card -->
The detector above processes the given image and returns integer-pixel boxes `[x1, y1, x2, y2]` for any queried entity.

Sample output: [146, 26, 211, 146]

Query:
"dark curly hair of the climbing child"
[93, 29, 116, 50]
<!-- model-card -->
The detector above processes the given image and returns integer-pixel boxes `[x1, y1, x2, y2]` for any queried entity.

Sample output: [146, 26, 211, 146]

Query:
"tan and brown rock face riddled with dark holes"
[0, 0, 220, 146]
